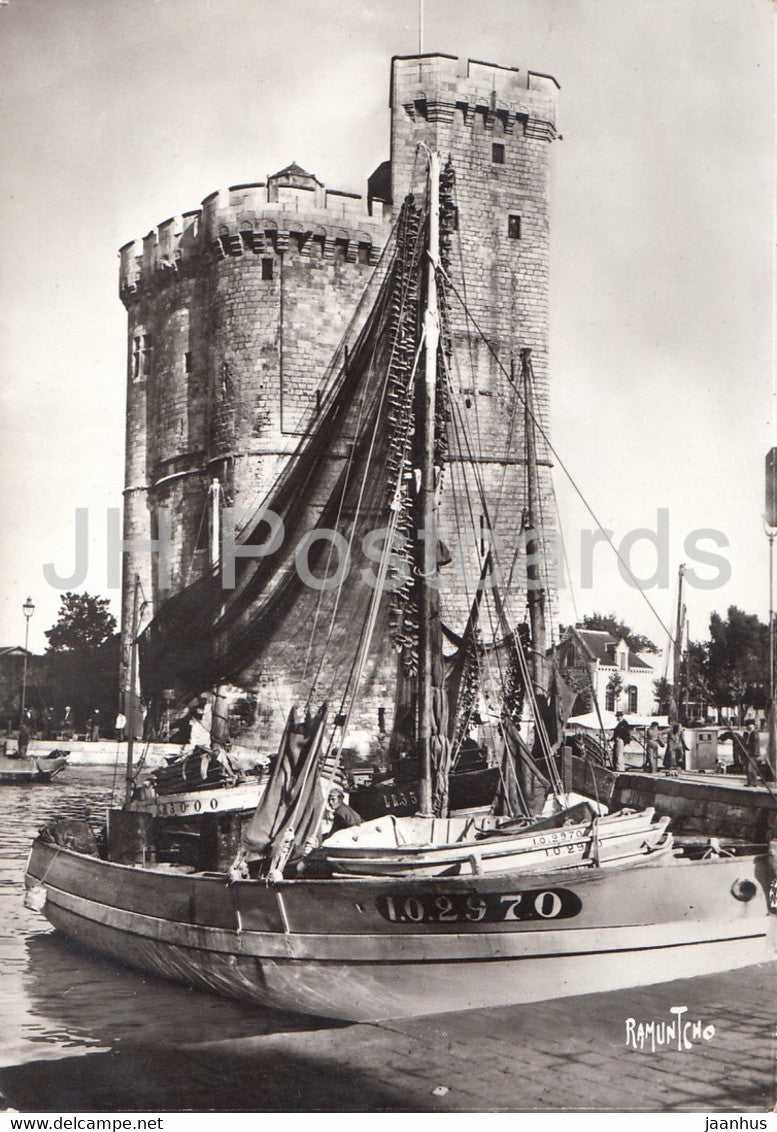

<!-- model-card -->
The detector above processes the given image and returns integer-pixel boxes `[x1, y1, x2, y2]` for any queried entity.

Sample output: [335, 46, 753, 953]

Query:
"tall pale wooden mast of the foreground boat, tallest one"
[416, 153, 439, 814]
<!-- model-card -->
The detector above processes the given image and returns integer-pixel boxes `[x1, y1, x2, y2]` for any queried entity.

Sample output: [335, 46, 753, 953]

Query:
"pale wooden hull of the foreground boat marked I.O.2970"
[26, 841, 777, 1021]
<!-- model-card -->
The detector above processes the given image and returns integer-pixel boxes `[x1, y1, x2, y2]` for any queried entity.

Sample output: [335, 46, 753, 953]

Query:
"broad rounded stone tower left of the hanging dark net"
[120, 165, 385, 687]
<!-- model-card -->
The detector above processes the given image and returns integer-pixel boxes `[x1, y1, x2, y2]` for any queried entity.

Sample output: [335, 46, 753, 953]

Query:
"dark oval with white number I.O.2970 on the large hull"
[376, 889, 582, 924]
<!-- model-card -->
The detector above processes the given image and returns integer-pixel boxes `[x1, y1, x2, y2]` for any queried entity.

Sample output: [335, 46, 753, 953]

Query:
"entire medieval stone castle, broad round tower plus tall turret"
[120, 55, 557, 734]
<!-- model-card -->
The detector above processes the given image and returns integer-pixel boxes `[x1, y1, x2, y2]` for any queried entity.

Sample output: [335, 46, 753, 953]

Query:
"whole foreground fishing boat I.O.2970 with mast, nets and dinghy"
[26, 154, 777, 1020]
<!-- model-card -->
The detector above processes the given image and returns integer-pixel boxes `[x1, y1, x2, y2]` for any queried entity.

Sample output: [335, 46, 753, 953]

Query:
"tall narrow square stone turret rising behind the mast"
[391, 55, 558, 620]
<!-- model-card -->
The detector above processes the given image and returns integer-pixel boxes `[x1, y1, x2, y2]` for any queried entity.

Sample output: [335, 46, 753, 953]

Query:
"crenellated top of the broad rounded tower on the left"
[119, 164, 385, 305]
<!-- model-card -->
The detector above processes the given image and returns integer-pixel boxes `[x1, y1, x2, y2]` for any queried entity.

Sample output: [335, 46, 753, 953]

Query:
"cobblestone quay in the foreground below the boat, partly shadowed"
[0, 963, 777, 1112]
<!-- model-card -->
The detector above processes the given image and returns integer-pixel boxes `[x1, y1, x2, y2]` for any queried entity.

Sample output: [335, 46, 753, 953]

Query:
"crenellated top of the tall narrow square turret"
[391, 55, 558, 140]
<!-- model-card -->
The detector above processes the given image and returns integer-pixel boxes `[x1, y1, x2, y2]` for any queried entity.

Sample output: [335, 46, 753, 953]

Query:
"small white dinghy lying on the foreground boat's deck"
[311, 808, 673, 876]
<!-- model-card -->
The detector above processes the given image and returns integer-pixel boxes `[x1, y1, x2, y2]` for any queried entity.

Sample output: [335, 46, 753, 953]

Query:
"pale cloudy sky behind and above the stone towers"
[0, 0, 777, 649]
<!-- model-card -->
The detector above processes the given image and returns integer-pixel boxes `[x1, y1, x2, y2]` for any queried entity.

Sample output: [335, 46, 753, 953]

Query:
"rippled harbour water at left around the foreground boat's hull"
[0, 769, 335, 1065]
